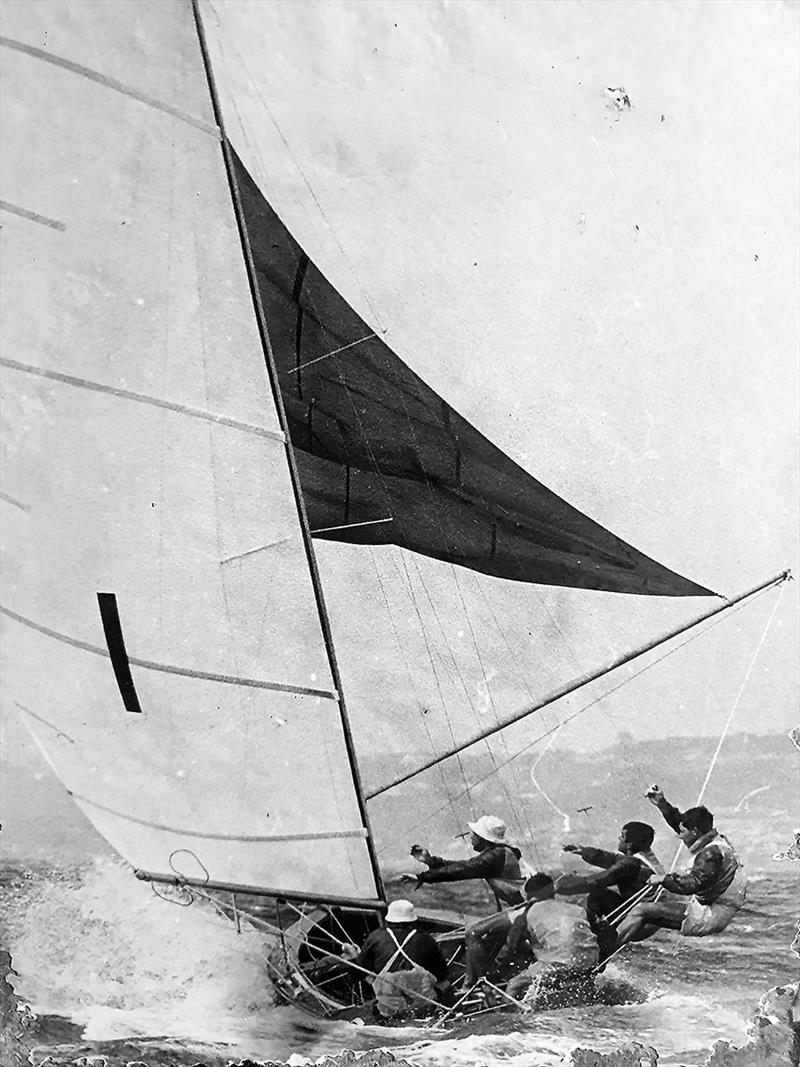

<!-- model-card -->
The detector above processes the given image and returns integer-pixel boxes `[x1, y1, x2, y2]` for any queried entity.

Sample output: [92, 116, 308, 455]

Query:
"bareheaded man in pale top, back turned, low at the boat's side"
[497, 873, 599, 1007]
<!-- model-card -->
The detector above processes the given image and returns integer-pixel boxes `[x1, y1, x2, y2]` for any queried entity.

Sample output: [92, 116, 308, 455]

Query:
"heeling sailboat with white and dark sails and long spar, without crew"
[0, 0, 786, 1014]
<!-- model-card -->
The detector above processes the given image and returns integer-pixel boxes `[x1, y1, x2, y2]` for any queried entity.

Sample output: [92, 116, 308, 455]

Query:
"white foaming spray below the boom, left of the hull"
[5, 860, 275, 1040]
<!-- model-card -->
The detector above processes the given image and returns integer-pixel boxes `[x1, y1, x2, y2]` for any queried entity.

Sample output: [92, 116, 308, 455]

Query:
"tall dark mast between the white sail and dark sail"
[192, 0, 386, 903]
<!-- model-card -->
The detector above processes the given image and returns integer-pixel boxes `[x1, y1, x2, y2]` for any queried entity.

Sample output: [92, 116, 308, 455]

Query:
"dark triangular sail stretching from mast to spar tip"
[237, 154, 709, 596]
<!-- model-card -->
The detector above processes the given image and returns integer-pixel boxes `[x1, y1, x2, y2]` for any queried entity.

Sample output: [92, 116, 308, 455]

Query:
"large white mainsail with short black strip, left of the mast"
[0, 0, 378, 901]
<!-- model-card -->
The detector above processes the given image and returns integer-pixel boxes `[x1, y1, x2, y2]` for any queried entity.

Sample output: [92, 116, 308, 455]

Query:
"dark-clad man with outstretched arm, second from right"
[556, 823, 665, 961]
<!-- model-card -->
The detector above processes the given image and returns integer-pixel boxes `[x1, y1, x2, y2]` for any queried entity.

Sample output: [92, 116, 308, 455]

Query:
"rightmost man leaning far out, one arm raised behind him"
[617, 785, 747, 944]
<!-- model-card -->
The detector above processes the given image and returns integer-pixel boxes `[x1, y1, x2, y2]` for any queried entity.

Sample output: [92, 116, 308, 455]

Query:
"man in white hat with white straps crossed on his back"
[339, 901, 449, 1019]
